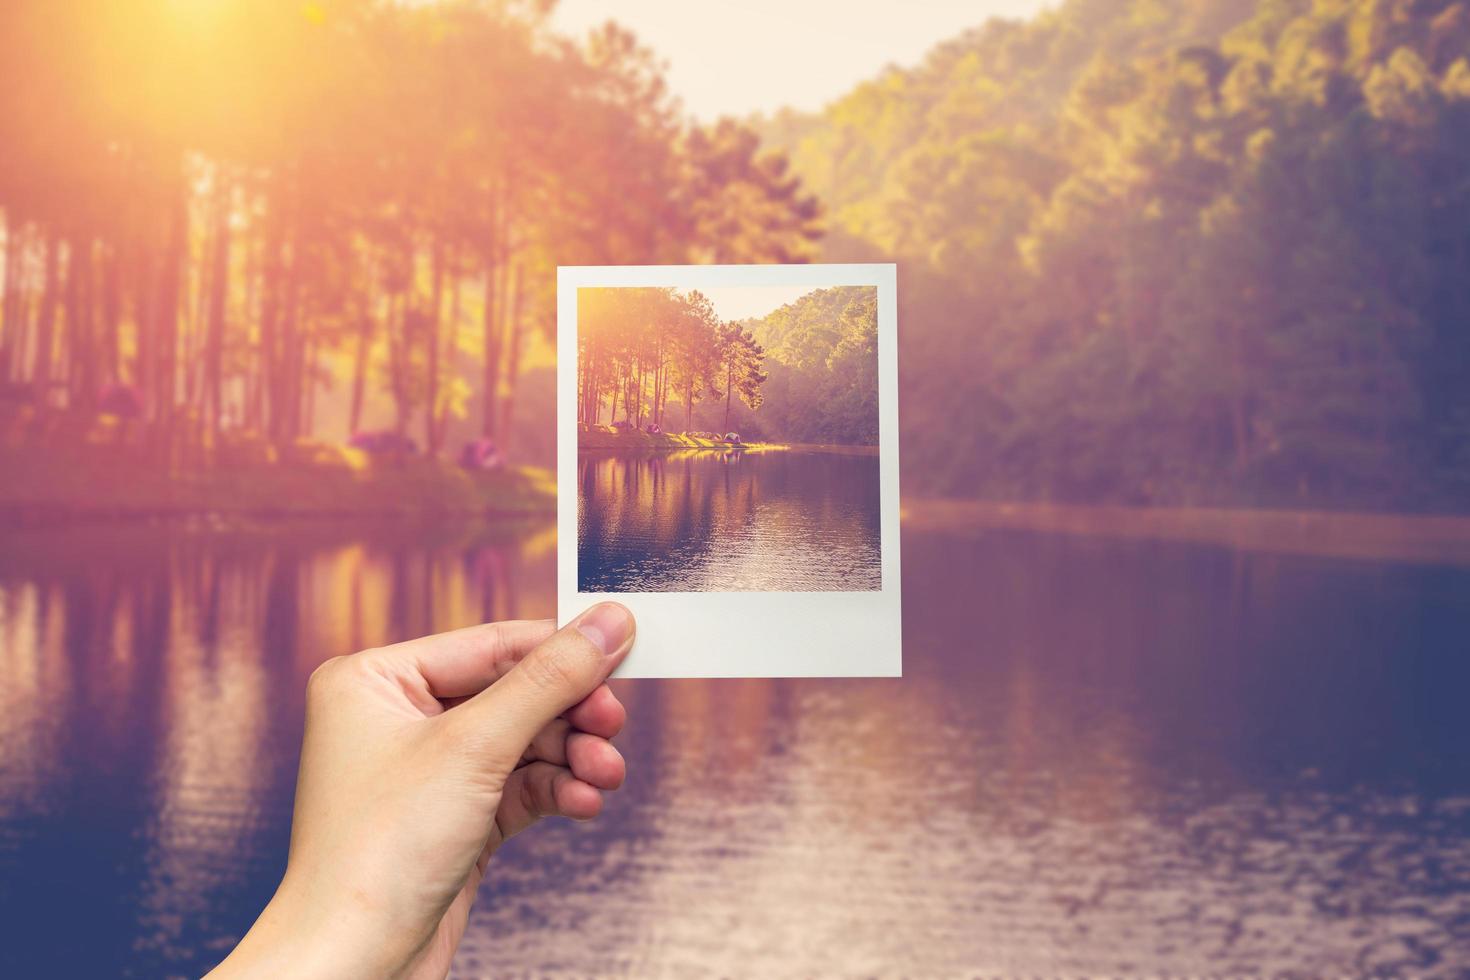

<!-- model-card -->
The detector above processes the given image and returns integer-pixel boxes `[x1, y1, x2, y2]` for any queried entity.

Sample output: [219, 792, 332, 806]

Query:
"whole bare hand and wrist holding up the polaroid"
[210, 602, 634, 977]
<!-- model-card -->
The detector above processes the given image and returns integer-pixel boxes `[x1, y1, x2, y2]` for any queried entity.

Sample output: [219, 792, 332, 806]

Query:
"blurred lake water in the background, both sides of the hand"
[0, 517, 1470, 977]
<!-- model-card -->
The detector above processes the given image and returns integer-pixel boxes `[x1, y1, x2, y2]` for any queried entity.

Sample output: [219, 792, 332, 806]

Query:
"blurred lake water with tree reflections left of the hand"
[0, 526, 554, 976]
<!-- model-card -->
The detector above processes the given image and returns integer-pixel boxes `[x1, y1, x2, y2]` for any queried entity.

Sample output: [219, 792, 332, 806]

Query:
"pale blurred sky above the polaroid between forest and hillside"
[553, 0, 1054, 122]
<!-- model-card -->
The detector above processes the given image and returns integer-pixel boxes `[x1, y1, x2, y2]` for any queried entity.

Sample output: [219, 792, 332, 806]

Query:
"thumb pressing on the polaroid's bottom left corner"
[448, 602, 634, 773]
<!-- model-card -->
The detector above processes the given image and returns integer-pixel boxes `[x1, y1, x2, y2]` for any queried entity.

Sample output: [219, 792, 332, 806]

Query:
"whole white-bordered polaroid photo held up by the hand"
[557, 264, 903, 677]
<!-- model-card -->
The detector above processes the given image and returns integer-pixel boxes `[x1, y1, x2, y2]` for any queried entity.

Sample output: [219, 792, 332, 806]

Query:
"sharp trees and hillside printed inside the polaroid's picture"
[576, 287, 878, 445]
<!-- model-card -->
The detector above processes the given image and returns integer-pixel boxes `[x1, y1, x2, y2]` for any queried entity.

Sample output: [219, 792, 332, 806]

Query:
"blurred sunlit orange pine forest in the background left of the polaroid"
[0, 0, 819, 464]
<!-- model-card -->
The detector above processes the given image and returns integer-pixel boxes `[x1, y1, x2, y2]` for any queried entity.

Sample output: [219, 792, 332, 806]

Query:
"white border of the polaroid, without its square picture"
[556, 263, 903, 677]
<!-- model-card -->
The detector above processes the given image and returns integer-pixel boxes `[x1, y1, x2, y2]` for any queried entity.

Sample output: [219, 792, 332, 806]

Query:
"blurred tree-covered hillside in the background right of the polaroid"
[757, 0, 1470, 510]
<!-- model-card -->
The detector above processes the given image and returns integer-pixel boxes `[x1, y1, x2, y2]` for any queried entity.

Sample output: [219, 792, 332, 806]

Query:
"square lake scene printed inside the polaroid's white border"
[576, 285, 882, 592]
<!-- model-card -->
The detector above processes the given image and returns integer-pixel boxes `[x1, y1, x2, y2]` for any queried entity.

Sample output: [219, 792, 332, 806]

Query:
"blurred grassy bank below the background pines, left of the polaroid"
[0, 417, 556, 526]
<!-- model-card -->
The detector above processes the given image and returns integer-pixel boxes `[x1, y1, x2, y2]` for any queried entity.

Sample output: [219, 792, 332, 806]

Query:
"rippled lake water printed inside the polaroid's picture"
[578, 451, 882, 592]
